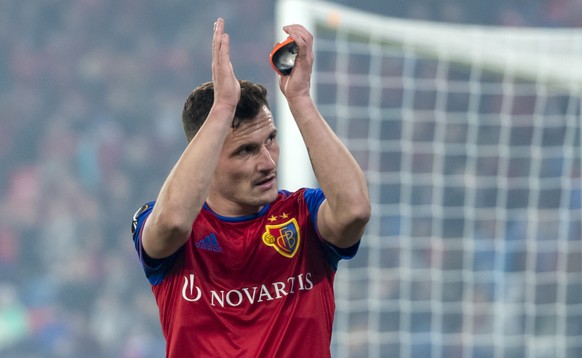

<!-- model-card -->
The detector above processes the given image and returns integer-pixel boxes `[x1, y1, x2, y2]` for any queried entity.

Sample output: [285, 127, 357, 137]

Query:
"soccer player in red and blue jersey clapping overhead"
[132, 19, 371, 358]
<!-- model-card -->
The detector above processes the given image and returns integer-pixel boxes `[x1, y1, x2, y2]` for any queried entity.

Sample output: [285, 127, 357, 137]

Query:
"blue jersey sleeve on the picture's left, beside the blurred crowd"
[131, 201, 180, 285]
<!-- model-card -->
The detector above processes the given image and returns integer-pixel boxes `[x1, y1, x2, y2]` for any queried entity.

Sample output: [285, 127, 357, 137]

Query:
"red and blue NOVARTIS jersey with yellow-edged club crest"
[133, 189, 358, 358]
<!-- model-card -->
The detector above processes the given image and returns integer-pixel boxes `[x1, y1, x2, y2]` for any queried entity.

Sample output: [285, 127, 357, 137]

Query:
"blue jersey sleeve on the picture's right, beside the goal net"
[303, 188, 360, 270]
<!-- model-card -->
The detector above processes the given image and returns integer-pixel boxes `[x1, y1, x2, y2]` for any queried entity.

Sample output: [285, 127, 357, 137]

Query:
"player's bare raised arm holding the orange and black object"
[279, 25, 371, 248]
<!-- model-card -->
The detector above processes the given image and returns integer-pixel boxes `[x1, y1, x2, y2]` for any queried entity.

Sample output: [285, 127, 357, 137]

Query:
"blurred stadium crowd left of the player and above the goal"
[0, 0, 582, 358]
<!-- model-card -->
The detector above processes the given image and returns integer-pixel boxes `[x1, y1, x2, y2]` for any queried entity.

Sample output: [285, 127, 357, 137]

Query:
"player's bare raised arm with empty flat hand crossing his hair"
[142, 19, 240, 258]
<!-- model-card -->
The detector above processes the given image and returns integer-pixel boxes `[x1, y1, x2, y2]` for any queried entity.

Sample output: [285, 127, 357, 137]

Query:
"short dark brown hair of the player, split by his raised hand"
[182, 80, 269, 142]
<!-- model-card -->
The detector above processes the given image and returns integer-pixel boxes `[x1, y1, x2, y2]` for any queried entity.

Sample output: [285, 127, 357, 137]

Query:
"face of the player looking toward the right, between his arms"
[207, 107, 279, 216]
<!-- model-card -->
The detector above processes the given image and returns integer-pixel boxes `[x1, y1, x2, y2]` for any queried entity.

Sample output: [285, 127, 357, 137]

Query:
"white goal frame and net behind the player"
[277, 0, 582, 358]
